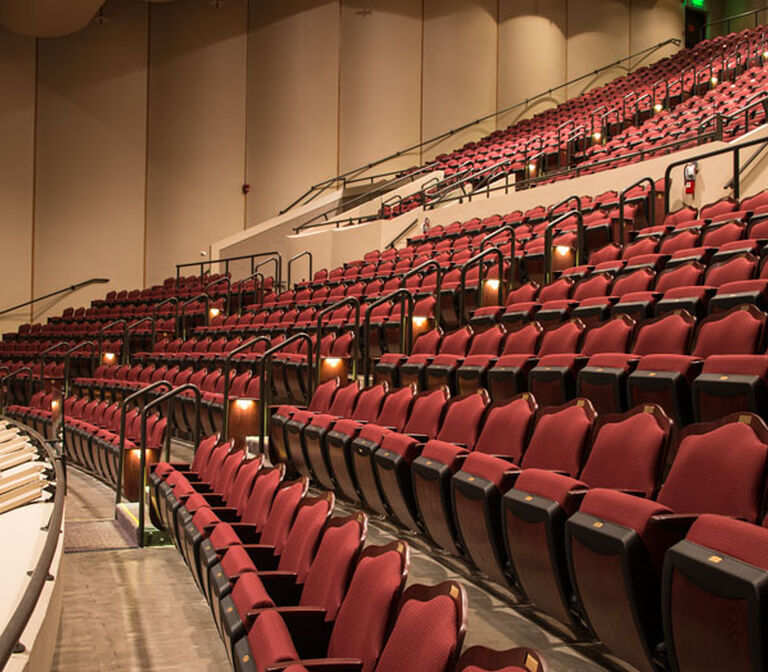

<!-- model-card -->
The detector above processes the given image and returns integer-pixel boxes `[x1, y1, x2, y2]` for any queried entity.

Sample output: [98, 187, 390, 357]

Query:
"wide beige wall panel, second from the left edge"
[33, 0, 148, 319]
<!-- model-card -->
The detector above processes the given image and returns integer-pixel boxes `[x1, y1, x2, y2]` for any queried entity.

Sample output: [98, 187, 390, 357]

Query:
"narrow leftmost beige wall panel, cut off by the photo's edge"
[0, 29, 35, 331]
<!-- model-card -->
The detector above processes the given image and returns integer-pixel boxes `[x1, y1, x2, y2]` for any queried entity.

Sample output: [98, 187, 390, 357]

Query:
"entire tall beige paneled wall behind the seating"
[0, 0, 688, 326]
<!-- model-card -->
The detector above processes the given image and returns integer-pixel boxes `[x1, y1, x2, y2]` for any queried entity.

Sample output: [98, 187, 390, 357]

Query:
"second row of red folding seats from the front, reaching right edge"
[270, 383, 768, 670]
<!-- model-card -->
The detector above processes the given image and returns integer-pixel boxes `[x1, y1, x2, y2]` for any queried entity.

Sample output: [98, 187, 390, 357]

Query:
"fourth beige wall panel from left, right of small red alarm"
[248, 0, 340, 225]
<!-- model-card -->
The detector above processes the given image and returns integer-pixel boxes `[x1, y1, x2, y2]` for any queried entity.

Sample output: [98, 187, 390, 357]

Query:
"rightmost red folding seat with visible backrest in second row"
[566, 414, 768, 671]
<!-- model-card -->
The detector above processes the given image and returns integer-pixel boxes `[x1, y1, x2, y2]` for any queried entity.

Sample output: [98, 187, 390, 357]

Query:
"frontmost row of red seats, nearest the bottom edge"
[146, 436, 548, 672]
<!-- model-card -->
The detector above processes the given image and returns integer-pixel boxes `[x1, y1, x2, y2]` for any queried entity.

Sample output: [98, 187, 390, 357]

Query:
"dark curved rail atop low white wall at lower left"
[0, 418, 66, 669]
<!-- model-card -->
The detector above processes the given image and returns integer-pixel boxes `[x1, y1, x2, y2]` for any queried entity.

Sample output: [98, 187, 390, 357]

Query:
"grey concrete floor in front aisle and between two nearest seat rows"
[52, 460, 629, 672]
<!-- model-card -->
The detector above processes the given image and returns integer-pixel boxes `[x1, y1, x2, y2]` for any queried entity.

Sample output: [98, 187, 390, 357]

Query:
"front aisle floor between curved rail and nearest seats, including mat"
[51, 469, 229, 672]
